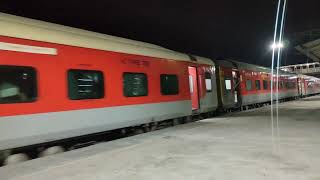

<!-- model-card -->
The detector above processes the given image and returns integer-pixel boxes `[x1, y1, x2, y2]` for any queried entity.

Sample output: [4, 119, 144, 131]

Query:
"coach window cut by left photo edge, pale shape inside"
[0, 66, 37, 104]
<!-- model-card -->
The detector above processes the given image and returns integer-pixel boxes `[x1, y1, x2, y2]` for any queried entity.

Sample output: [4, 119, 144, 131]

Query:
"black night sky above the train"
[0, 0, 320, 65]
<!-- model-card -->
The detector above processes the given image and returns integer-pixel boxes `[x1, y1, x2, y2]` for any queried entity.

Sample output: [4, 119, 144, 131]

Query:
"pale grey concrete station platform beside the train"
[0, 96, 320, 180]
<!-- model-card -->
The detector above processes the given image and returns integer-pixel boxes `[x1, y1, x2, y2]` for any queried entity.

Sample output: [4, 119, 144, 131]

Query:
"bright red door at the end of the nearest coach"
[188, 66, 199, 110]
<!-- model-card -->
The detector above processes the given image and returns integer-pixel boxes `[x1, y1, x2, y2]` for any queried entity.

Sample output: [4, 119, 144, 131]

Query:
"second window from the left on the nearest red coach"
[68, 69, 104, 100]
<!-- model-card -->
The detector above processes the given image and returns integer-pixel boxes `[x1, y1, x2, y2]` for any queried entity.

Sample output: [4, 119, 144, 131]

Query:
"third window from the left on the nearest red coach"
[123, 72, 148, 97]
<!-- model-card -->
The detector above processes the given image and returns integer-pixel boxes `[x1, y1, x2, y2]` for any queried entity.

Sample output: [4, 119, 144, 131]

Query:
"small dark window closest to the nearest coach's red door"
[160, 74, 179, 95]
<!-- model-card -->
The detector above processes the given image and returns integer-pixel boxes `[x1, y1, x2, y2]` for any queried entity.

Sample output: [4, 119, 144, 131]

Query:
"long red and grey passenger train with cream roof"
[0, 13, 320, 164]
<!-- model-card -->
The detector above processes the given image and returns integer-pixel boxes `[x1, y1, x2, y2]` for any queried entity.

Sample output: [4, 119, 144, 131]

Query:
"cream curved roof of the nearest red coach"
[0, 13, 213, 65]
